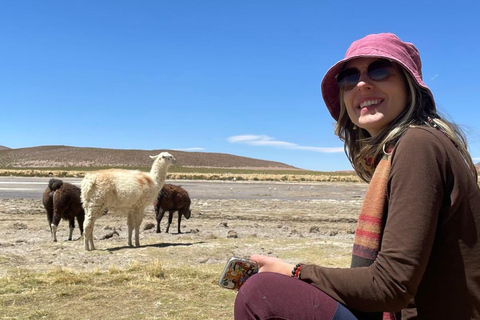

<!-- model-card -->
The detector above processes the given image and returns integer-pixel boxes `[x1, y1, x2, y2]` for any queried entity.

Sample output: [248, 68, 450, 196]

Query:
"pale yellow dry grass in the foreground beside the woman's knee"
[0, 238, 350, 320]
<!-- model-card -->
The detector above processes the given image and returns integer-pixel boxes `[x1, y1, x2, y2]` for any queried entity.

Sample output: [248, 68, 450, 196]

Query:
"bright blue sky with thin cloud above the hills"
[0, 0, 480, 171]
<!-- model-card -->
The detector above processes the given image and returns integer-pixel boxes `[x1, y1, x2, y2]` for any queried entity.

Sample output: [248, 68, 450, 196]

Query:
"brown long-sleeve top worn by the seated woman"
[301, 127, 480, 320]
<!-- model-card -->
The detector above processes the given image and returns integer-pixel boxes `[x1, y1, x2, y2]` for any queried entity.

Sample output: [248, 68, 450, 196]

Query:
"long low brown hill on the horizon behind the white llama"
[0, 146, 298, 169]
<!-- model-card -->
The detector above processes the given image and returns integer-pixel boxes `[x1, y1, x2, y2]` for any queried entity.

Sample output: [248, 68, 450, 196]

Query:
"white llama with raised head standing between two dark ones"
[81, 152, 175, 250]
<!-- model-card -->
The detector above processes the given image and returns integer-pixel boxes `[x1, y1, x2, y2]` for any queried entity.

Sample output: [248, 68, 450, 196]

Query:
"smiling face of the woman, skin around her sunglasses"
[343, 58, 408, 137]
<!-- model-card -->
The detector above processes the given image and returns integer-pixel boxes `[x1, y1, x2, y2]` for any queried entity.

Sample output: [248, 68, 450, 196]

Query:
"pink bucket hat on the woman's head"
[322, 33, 435, 121]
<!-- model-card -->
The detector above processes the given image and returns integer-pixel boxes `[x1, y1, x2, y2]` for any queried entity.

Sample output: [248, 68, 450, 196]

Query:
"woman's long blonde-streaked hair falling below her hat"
[335, 68, 478, 182]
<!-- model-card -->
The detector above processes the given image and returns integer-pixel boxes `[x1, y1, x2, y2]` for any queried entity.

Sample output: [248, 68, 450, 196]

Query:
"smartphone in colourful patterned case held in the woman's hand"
[218, 257, 258, 290]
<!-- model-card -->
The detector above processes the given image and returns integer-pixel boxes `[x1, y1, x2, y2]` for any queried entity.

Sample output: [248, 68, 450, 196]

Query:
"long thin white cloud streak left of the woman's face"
[227, 135, 343, 153]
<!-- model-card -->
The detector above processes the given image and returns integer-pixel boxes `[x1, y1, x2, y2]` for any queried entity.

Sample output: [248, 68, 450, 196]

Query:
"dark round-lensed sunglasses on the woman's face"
[335, 59, 393, 91]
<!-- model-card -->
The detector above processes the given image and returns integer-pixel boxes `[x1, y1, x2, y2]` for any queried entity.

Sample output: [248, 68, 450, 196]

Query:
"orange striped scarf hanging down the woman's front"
[351, 149, 396, 320]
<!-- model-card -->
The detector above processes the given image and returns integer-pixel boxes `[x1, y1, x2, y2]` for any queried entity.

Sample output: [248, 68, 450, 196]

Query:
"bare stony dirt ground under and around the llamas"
[0, 183, 366, 276]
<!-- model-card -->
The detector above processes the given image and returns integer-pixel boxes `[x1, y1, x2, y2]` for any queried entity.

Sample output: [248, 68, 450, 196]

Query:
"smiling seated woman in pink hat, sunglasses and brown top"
[235, 33, 480, 320]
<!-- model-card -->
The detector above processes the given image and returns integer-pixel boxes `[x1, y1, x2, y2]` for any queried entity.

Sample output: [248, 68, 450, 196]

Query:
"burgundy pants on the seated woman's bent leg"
[235, 272, 357, 320]
